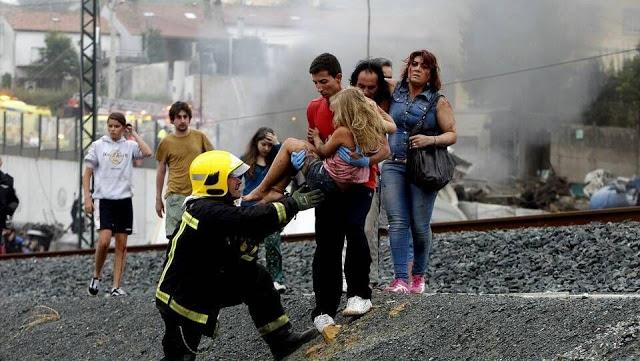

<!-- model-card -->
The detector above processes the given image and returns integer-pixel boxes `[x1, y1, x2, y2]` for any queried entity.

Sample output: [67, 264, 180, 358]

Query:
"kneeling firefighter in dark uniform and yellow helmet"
[156, 150, 323, 361]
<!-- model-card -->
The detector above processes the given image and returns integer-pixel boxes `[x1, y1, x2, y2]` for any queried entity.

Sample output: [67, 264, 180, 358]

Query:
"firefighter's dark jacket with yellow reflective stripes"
[156, 196, 298, 334]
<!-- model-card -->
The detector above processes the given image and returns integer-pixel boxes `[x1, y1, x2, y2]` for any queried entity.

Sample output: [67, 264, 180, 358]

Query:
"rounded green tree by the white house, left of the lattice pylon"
[30, 32, 80, 89]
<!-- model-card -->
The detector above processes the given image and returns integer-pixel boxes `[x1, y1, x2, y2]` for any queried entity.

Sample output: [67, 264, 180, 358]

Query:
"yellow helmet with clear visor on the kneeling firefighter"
[189, 150, 249, 197]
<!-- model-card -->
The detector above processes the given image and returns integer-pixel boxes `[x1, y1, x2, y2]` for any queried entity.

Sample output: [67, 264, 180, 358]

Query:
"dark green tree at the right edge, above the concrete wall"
[584, 45, 640, 127]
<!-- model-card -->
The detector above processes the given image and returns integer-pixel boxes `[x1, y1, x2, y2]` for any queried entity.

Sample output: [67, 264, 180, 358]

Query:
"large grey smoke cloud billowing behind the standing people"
[195, 0, 633, 178]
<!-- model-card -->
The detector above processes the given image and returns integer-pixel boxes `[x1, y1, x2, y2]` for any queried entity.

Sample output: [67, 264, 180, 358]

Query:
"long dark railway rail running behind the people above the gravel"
[0, 207, 640, 261]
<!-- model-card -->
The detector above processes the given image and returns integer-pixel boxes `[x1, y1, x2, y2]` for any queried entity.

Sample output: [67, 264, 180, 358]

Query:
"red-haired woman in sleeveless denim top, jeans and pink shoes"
[381, 50, 457, 293]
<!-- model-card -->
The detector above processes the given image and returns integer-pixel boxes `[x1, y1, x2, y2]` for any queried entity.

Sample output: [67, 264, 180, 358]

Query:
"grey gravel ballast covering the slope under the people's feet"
[0, 222, 640, 360]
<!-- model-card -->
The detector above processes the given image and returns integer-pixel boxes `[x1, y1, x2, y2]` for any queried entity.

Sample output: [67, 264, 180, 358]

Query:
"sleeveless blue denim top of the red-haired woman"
[389, 81, 440, 161]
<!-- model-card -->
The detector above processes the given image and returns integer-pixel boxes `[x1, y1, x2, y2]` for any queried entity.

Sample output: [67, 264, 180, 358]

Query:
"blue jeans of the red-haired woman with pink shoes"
[382, 161, 438, 281]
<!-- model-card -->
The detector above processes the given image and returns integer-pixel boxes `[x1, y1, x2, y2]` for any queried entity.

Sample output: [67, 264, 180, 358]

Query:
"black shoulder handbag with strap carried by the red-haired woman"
[407, 97, 456, 192]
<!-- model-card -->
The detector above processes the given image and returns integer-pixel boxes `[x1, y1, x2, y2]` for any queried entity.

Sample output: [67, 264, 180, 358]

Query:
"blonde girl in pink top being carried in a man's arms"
[243, 87, 396, 202]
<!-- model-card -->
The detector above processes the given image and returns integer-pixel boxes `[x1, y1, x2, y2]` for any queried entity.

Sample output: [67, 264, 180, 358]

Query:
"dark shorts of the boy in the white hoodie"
[93, 198, 133, 234]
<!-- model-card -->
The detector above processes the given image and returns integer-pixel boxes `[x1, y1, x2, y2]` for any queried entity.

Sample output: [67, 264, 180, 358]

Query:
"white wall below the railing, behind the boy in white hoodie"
[2, 155, 164, 245]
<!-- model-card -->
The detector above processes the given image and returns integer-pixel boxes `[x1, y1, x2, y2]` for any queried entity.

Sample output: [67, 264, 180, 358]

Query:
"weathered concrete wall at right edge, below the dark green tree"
[551, 125, 640, 182]
